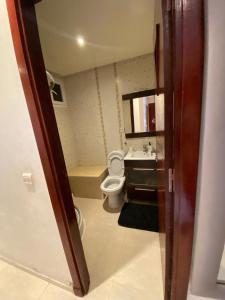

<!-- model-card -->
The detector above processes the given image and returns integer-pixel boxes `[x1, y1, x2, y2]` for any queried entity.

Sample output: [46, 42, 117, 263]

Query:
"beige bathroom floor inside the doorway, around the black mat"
[75, 198, 163, 300]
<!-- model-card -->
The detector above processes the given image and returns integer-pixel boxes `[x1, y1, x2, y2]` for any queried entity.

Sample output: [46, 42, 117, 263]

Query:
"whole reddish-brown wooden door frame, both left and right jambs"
[6, 0, 204, 300]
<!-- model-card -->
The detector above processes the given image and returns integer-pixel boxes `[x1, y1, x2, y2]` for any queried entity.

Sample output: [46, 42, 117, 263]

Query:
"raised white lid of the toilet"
[108, 153, 124, 177]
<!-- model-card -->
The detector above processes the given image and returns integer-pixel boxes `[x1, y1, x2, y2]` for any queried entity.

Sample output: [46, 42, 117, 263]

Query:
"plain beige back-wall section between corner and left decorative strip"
[64, 70, 105, 165]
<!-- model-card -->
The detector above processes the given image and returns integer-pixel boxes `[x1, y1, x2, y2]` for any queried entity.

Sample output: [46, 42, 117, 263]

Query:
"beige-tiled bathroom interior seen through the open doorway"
[36, 0, 164, 299]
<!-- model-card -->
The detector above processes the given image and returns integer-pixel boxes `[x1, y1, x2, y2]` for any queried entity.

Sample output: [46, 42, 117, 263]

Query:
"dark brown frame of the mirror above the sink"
[122, 88, 164, 139]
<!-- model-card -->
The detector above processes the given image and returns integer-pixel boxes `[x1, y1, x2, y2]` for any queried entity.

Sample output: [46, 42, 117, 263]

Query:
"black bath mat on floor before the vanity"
[118, 203, 159, 232]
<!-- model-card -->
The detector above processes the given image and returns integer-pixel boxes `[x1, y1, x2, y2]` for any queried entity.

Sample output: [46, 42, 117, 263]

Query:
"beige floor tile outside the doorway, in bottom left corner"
[0, 266, 48, 300]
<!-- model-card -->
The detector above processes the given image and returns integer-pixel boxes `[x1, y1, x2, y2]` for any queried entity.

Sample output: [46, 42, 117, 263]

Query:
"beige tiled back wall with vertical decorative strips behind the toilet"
[55, 54, 156, 165]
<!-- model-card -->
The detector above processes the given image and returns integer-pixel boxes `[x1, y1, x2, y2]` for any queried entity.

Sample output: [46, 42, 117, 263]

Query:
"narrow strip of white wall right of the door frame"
[188, 0, 225, 299]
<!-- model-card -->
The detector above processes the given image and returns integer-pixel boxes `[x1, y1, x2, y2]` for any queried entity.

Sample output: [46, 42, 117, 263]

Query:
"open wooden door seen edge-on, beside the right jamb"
[156, 0, 174, 300]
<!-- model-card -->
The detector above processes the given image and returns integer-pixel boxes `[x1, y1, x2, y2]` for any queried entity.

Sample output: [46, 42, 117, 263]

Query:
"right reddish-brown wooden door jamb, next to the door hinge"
[168, 0, 204, 300]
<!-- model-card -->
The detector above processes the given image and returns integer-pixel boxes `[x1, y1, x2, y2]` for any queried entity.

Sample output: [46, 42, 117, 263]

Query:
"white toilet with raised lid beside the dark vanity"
[100, 150, 125, 209]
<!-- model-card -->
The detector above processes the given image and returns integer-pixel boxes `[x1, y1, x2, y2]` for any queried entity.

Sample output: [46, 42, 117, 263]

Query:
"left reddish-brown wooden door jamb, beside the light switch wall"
[7, 0, 89, 296]
